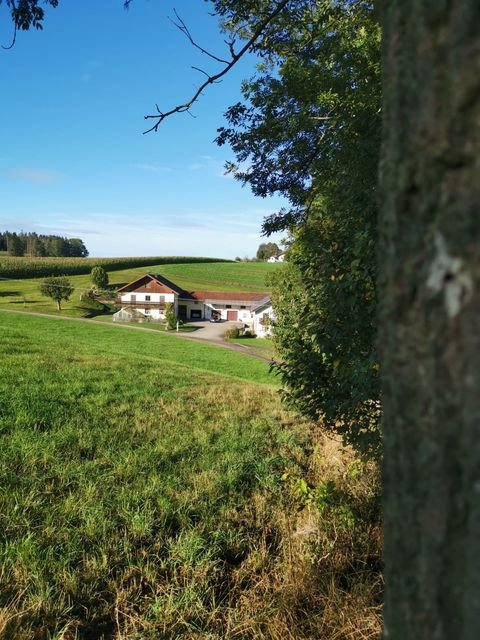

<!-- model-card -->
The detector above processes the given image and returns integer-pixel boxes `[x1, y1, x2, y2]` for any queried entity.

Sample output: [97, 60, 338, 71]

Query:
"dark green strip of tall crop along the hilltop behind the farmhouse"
[0, 256, 231, 279]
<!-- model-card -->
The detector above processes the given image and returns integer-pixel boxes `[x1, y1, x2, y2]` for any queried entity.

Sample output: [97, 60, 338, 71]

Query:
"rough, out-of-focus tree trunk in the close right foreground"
[379, 0, 480, 640]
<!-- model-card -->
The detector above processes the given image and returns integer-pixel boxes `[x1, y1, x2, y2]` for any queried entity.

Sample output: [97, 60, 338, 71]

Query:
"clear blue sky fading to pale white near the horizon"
[0, 0, 283, 258]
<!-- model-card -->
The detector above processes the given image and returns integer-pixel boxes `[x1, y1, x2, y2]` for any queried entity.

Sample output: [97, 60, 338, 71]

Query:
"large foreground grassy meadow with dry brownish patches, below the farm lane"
[0, 312, 381, 640]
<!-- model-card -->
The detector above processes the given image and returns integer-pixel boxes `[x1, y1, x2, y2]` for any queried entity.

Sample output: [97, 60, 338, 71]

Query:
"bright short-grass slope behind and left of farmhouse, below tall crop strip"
[0, 262, 281, 317]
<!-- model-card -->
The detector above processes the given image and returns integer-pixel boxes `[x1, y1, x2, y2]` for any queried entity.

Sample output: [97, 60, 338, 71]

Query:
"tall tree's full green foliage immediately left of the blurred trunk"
[217, 0, 381, 453]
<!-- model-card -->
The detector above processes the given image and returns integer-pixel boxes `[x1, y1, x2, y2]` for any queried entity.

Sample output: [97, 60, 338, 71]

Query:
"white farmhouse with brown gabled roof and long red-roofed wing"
[113, 273, 269, 325]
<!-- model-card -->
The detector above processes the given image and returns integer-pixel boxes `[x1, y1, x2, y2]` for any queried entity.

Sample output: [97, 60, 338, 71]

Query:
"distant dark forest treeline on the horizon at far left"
[0, 231, 88, 258]
